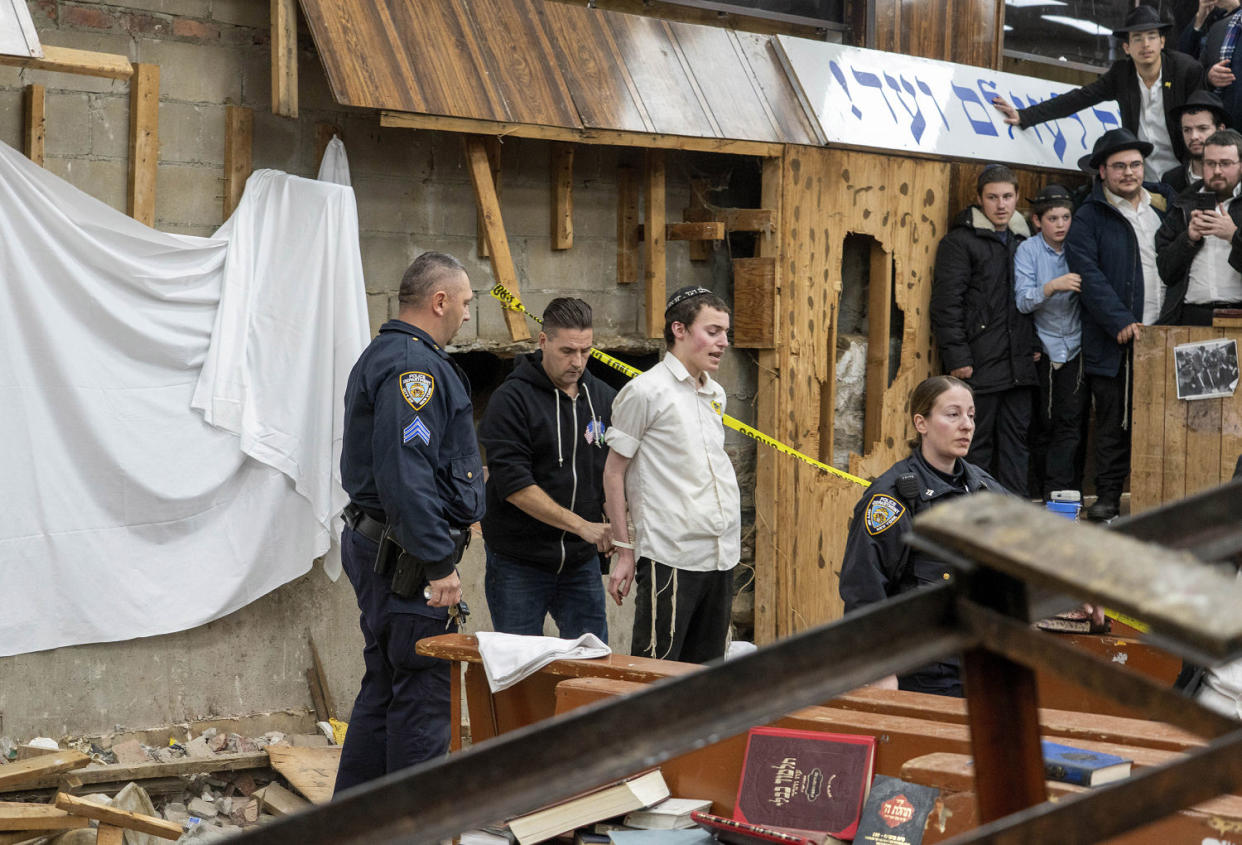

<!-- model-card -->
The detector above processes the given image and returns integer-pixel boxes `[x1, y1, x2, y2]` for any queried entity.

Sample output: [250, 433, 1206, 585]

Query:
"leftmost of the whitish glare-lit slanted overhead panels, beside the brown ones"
[605, 12, 720, 137]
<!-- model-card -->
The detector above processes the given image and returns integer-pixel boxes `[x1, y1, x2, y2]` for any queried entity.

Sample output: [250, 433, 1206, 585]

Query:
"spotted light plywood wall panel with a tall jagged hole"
[755, 147, 949, 637]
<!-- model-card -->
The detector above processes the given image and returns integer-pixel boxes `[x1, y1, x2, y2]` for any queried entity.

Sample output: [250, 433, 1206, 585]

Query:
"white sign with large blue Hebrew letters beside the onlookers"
[776, 35, 1122, 170]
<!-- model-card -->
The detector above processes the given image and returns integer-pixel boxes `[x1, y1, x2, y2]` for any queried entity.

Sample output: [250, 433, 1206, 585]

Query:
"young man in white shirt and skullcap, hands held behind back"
[604, 287, 741, 664]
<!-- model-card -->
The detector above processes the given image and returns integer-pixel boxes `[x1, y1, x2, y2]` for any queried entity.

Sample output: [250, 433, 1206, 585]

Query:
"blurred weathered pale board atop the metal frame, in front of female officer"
[909, 493, 1242, 664]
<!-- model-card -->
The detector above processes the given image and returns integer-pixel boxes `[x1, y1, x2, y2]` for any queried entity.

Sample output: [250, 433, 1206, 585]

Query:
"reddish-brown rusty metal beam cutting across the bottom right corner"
[945, 726, 1242, 845]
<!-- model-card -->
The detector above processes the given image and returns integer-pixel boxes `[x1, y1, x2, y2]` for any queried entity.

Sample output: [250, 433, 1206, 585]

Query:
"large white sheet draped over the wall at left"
[0, 144, 369, 656]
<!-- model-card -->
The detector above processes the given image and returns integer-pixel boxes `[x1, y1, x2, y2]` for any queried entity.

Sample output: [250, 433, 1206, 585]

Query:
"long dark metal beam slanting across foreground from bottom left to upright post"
[233, 583, 976, 845]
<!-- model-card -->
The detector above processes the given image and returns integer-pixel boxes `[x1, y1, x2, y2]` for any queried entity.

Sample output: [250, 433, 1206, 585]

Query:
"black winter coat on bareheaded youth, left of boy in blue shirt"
[932, 205, 1040, 393]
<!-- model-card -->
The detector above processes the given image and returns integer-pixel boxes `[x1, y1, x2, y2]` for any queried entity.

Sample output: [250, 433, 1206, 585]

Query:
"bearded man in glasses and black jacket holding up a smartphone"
[1156, 129, 1242, 326]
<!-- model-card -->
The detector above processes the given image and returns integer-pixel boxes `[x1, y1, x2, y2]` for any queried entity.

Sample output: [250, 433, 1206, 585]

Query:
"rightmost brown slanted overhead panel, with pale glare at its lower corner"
[539, 2, 656, 132]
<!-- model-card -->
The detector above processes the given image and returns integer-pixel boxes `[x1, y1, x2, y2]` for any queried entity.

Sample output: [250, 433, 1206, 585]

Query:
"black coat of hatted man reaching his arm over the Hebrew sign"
[1017, 50, 1203, 162]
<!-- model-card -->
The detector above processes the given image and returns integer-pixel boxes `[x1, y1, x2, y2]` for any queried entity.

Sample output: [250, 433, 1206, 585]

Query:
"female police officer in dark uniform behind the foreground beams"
[841, 375, 1005, 696]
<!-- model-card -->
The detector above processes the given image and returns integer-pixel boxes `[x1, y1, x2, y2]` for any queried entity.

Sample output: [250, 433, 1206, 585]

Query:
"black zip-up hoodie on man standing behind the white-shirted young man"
[478, 352, 617, 572]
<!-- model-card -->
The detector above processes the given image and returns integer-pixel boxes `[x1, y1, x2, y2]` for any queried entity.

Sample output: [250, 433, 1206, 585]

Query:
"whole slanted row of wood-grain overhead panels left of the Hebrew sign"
[301, 0, 815, 144]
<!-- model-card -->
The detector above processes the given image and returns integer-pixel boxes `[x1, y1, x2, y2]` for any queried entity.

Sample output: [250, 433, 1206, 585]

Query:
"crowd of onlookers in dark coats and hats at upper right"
[932, 0, 1242, 519]
